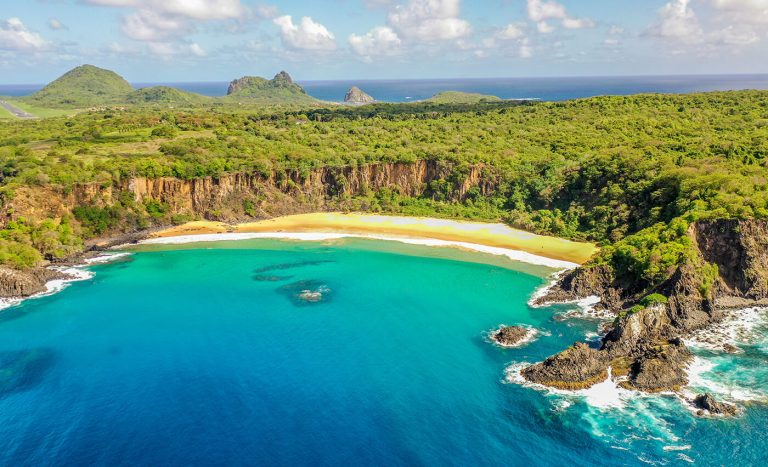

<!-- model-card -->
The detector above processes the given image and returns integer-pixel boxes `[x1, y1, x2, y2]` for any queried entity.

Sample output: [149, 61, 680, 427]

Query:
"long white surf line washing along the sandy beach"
[141, 232, 579, 269]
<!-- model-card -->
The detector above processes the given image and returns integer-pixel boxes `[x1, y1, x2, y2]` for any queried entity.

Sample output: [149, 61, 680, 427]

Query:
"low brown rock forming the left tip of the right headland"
[522, 343, 609, 389]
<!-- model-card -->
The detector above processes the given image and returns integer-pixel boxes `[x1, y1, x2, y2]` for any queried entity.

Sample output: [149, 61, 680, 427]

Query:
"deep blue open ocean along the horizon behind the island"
[0, 75, 768, 102]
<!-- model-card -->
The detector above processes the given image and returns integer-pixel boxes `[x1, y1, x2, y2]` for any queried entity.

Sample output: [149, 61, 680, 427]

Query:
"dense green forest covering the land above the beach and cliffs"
[0, 91, 768, 292]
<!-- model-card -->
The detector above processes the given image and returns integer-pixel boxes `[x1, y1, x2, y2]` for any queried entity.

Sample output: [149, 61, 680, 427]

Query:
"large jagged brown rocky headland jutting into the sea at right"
[523, 220, 768, 392]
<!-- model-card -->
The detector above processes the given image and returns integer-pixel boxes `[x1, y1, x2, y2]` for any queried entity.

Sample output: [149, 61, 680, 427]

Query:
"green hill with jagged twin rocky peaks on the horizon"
[225, 71, 319, 104]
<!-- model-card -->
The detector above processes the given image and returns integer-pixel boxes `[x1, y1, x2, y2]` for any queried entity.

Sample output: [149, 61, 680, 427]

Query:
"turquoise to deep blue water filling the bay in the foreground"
[0, 240, 768, 466]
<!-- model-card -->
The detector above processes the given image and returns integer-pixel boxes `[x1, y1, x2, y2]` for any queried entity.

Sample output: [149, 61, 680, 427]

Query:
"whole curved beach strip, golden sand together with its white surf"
[147, 213, 597, 269]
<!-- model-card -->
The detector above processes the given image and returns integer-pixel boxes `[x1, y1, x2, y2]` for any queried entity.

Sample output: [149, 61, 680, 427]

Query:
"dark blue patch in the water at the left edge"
[0, 348, 55, 397]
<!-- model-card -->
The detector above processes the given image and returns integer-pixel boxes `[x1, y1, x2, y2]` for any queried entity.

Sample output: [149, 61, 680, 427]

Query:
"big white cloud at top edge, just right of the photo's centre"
[387, 0, 472, 41]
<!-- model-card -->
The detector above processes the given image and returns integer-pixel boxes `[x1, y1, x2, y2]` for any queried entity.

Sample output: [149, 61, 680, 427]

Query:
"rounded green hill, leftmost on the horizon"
[23, 65, 133, 109]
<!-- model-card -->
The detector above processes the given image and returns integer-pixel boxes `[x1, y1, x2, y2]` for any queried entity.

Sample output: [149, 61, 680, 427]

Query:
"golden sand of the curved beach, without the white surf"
[152, 213, 597, 264]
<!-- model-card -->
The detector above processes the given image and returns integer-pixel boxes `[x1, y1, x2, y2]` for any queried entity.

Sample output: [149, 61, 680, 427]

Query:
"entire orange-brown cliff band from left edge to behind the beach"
[0, 161, 496, 227]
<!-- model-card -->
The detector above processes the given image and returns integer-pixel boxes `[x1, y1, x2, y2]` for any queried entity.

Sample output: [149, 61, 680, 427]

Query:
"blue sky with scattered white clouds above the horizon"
[0, 0, 768, 84]
